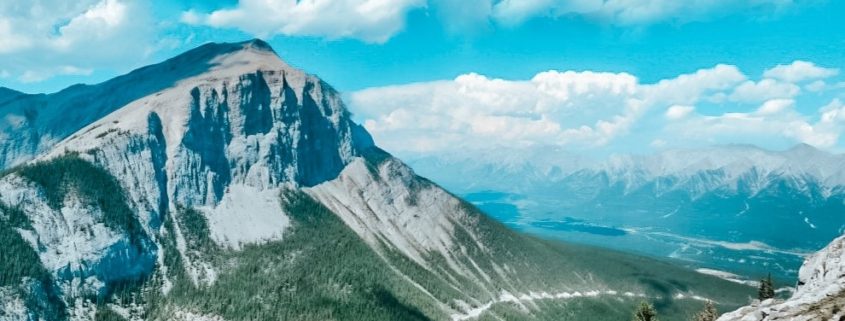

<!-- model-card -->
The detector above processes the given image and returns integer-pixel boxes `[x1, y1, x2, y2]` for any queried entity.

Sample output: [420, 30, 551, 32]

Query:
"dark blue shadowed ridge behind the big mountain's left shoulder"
[0, 40, 272, 167]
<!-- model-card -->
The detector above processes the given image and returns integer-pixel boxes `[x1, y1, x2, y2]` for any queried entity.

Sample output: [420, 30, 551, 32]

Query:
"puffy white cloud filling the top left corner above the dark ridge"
[0, 0, 153, 82]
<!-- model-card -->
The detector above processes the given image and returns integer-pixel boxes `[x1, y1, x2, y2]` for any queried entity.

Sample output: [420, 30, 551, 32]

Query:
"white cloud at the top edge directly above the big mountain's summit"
[182, 0, 426, 43]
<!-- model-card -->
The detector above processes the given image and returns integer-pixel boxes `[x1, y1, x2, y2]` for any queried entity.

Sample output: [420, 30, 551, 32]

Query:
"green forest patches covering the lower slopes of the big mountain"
[0, 153, 753, 321]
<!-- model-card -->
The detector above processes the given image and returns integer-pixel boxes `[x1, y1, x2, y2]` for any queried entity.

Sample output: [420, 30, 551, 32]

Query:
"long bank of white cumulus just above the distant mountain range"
[349, 61, 845, 154]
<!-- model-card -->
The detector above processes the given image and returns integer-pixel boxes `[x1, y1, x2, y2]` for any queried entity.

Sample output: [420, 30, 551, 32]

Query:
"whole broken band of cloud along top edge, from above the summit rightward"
[183, 0, 802, 43]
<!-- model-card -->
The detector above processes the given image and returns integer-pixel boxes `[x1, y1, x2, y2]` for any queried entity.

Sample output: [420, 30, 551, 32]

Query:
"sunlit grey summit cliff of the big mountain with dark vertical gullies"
[48, 37, 372, 206]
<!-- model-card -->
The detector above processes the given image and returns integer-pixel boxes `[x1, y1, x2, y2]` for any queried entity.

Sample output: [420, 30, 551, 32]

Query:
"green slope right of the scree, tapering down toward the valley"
[454, 196, 754, 320]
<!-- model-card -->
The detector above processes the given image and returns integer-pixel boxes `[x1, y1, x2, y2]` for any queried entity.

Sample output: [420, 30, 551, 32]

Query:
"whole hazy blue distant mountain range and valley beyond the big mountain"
[409, 144, 845, 278]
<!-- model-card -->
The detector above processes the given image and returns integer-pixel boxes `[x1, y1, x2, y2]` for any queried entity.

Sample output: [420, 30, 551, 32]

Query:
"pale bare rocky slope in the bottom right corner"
[719, 232, 845, 321]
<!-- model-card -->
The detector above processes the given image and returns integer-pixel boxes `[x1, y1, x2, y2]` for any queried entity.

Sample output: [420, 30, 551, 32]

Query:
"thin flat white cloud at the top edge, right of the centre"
[493, 0, 793, 26]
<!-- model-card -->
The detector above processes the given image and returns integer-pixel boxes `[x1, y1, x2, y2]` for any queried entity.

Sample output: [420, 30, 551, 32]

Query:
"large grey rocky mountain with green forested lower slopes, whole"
[0, 40, 753, 321]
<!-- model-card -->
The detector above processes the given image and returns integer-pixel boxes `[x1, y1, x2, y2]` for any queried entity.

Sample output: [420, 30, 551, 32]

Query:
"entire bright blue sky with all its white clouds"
[0, 0, 845, 153]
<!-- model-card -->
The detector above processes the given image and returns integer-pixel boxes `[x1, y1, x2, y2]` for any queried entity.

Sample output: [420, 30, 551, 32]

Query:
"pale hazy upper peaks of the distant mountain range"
[408, 144, 845, 197]
